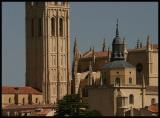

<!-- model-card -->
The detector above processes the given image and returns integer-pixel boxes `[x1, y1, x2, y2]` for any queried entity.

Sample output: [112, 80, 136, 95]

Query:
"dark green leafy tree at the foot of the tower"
[56, 94, 101, 116]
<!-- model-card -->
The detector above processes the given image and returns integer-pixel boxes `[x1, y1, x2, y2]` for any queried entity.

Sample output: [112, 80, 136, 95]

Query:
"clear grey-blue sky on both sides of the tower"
[2, 2, 158, 86]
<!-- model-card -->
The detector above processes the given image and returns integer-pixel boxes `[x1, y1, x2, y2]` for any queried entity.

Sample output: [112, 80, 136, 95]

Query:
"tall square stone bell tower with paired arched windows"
[26, 2, 70, 103]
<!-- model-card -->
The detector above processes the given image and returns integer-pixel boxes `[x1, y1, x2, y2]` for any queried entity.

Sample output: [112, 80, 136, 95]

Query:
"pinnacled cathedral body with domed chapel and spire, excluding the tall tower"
[71, 20, 158, 116]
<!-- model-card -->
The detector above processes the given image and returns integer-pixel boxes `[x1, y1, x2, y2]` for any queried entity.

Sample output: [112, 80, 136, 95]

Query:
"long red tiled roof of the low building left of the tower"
[2, 86, 42, 94]
